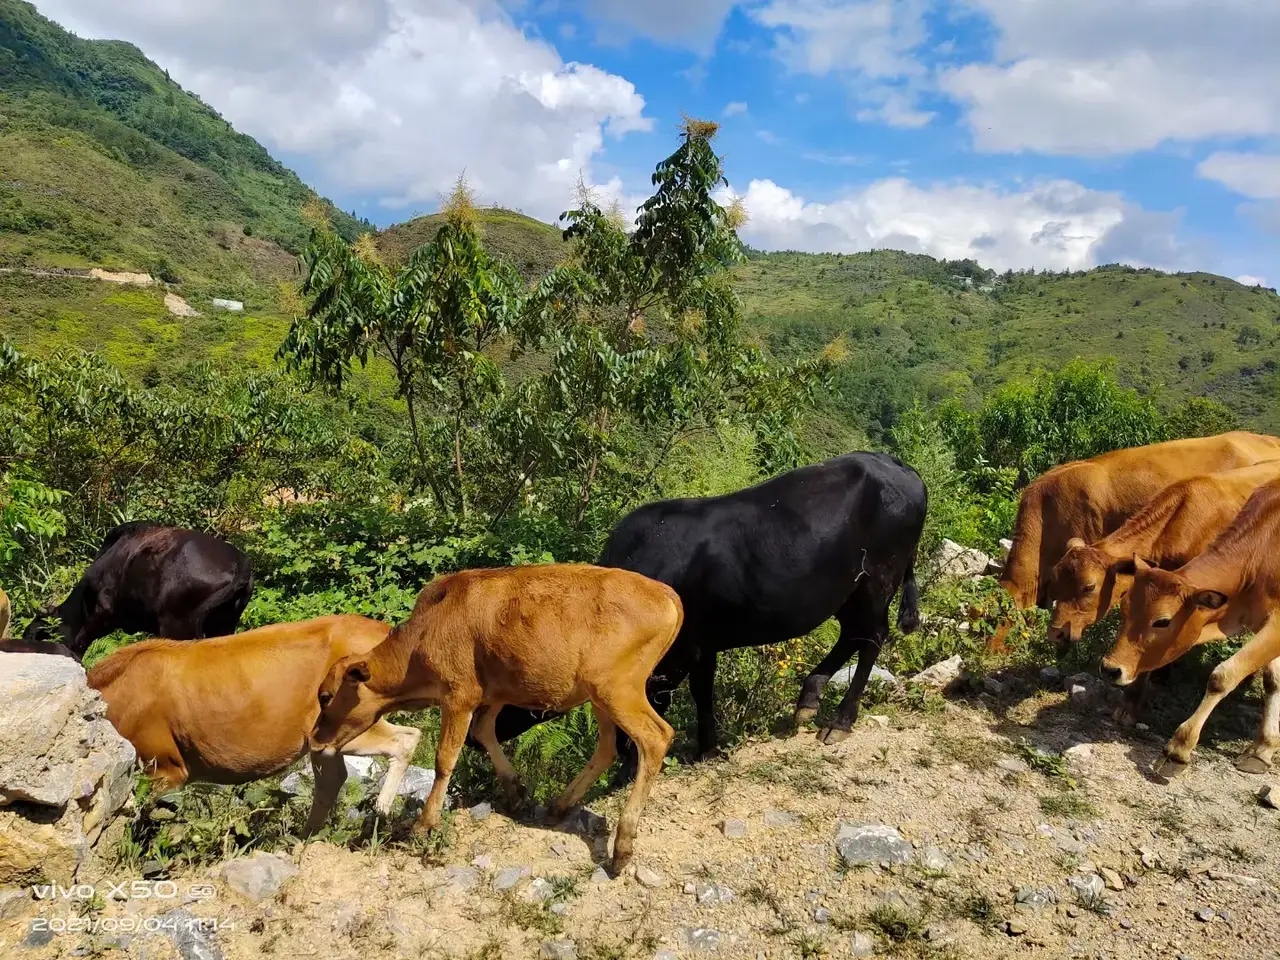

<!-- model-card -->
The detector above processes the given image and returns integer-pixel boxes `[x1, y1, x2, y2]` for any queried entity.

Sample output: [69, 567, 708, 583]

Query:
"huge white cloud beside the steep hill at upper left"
[41, 0, 650, 219]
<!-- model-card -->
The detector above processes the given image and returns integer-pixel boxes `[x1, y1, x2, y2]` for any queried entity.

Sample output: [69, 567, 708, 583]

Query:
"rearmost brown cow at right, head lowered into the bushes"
[991, 430, 1280, 648]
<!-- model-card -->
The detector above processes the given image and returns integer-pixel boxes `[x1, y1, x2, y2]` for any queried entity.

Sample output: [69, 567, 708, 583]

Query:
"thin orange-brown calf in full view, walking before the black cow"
[311, 563, 684, 874]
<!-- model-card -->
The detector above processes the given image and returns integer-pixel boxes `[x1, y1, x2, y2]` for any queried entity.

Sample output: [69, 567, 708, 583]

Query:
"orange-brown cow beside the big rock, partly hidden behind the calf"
[88, 616, 421, 833]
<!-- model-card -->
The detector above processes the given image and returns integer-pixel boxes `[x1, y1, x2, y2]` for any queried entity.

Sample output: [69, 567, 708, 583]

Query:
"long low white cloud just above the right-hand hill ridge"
[730, 178, 1203, 270]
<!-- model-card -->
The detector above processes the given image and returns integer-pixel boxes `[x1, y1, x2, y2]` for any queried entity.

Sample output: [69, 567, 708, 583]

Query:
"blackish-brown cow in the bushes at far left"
[22, 521, 253, 657]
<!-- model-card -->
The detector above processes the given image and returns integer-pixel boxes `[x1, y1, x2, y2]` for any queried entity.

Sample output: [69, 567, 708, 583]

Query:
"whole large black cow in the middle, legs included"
[486, 453, 928, 756]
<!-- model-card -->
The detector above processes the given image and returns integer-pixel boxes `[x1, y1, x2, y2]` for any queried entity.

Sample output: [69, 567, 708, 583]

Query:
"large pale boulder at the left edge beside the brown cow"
[0, 653, 137, 883]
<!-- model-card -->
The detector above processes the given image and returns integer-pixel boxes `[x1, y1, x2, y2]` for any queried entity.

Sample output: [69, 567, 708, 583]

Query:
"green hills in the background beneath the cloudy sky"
[0, 0, 1280, 435]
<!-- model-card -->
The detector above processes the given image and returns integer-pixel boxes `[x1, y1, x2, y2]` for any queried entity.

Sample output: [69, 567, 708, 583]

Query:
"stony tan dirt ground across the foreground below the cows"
[0, 692, 1280, 960]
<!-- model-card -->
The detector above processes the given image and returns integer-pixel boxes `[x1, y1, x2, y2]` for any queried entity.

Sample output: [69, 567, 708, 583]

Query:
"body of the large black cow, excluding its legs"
[600, 453, 927, 644]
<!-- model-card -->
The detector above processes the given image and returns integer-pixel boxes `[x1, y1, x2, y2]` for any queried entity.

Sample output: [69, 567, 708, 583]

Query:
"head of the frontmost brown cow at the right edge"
[1102, 557, 1229, 686]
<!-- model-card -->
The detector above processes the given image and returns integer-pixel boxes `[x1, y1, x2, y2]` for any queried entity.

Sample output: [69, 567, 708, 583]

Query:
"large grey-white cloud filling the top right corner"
[941, 0, 1280, 155]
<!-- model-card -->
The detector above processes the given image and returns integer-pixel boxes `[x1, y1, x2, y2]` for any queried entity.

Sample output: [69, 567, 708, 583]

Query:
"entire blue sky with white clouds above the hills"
[24, 0, 1280, 284]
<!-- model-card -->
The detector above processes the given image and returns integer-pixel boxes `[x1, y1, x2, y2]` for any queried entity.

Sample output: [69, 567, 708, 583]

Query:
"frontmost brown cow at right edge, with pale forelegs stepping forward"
[1102, 480, 1280, 776]
